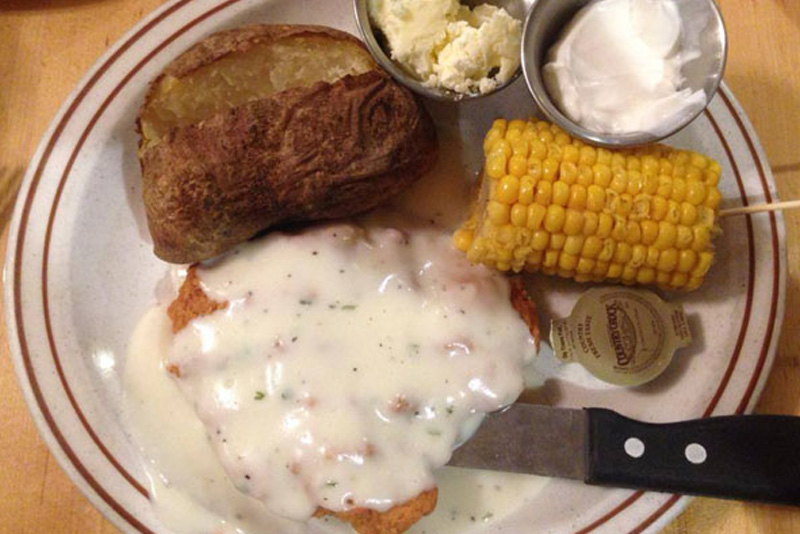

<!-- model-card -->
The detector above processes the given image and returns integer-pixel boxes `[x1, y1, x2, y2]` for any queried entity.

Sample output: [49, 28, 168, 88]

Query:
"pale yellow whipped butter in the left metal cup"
[369, 0, 522, 94]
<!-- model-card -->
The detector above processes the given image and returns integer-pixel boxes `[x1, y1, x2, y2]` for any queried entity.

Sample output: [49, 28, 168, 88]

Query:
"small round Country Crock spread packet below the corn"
[550, 287, 692, 386]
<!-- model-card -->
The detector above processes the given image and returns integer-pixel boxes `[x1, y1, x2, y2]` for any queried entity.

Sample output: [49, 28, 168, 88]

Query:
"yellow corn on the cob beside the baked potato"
[454, 119, 721, 290]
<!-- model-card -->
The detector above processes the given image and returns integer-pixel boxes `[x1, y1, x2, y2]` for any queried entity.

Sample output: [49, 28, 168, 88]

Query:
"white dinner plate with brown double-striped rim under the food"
[4, 0, 786, 534]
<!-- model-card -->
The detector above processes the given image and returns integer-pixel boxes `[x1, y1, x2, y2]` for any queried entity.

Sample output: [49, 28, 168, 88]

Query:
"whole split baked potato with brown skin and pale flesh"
[137, 25, 437, 263]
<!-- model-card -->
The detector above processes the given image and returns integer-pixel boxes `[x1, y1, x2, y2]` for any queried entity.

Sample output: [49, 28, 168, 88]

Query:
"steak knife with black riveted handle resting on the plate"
[449, 404, 800, 506]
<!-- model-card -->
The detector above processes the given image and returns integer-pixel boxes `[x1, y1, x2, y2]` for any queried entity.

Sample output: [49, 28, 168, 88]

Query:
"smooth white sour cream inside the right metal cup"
[542, 0, 706, 135]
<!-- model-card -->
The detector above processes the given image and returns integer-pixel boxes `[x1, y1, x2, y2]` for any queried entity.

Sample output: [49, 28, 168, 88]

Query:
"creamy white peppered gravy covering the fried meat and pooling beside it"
[126, 224, 541, 533]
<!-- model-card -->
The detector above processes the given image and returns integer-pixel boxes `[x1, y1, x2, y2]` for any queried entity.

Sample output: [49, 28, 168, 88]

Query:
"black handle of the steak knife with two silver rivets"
[586, 408, 800, 506]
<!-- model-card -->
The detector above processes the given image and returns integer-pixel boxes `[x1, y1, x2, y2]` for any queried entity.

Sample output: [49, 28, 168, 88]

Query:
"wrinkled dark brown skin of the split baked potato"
[139, 26, 437, 263]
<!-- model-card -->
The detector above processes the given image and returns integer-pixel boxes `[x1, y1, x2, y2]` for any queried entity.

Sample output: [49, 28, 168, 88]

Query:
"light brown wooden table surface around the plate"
[0, 0, 800, 534]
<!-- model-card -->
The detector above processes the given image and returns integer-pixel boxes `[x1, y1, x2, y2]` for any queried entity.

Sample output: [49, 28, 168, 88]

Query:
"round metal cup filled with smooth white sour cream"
[522, 0, 727, 146]
